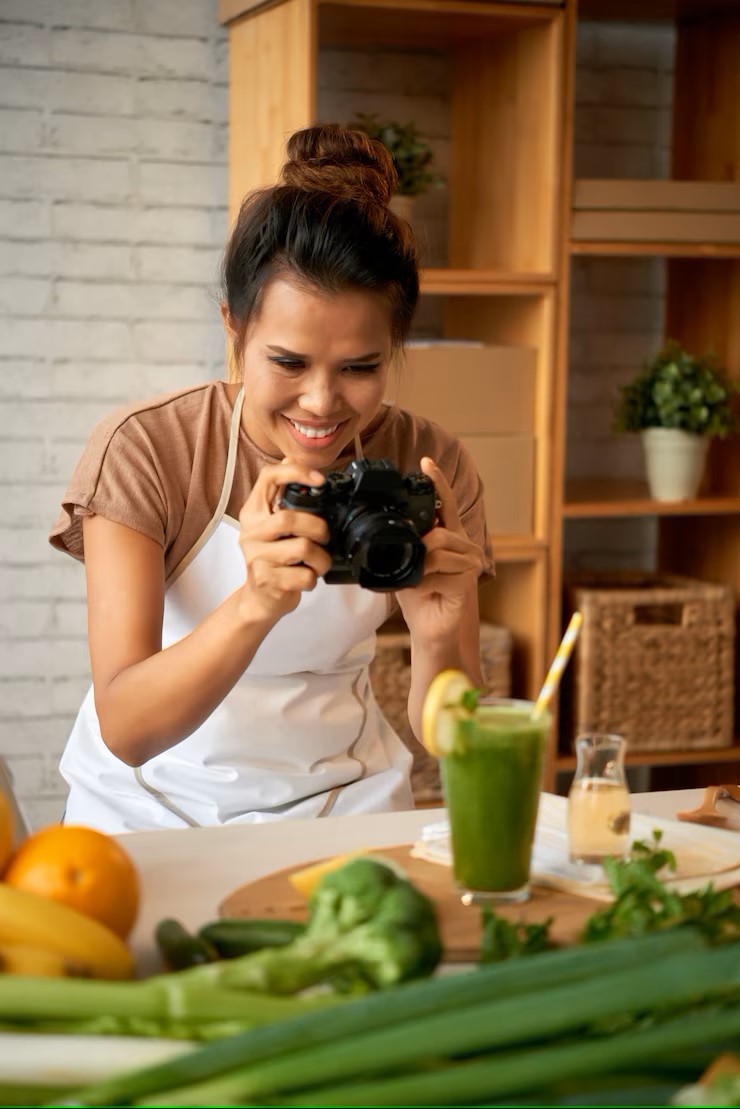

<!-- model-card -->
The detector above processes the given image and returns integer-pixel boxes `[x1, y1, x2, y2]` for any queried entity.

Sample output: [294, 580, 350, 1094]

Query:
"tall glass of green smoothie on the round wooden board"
[442, 701, 550, 899]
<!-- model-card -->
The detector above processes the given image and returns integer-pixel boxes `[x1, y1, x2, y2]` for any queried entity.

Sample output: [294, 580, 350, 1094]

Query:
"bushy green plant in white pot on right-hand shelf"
[615, 340, 739, 500]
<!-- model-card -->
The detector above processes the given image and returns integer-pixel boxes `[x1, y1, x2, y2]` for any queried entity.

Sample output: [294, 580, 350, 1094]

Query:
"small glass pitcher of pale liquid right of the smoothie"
[568, 732, 630, 863]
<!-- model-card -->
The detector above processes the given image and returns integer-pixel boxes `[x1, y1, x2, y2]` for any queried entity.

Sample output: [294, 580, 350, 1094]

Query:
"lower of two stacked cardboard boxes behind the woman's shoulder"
[460, 435, 535, 536]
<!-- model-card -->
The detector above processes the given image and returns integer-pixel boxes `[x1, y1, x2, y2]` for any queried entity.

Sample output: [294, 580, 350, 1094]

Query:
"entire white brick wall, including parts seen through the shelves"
[0, 0, 672, 825]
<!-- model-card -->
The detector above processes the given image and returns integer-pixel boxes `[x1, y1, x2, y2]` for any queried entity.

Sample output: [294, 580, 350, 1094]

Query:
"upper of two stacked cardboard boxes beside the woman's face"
[386, 344, 537, 435]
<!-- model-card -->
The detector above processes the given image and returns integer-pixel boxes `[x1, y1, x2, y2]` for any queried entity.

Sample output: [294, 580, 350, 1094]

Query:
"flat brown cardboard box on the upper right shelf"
[570, 180, 740, 243]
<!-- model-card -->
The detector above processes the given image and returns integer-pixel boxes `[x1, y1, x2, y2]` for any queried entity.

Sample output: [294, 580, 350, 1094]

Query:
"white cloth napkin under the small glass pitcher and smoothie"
[412, 793, 740, 901]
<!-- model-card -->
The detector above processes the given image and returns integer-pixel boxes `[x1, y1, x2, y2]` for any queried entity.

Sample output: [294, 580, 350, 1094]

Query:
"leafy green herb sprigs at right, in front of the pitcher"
[580, 831, 740, 944]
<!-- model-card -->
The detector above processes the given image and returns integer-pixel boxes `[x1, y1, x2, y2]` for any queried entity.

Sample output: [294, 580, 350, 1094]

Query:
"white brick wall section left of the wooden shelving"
[0, 0, 227, 825]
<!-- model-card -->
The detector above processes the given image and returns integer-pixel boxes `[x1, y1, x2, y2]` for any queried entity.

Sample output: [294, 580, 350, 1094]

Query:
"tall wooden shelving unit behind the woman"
[220, 0, 740, 798]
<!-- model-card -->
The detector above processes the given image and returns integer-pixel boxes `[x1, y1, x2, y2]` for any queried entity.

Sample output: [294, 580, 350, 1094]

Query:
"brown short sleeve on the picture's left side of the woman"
[49, 418, 169, 560]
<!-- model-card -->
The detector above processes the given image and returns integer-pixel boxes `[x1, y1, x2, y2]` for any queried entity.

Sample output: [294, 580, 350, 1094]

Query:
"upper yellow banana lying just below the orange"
[0, 882, 134, 978]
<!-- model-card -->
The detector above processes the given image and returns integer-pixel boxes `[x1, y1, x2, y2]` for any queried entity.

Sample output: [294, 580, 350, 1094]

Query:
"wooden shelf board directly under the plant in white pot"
[562, 478, 740, 520]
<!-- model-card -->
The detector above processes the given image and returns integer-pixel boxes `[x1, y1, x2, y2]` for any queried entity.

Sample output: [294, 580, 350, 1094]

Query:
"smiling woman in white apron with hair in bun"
[51, 124, 490, 833]
